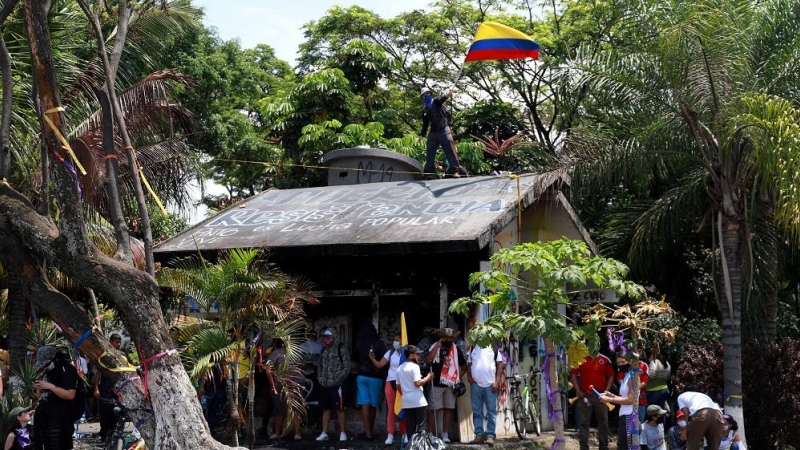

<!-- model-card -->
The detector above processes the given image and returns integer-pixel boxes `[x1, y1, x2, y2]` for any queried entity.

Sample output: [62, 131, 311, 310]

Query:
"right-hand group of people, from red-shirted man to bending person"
[571, 350, 744, 450]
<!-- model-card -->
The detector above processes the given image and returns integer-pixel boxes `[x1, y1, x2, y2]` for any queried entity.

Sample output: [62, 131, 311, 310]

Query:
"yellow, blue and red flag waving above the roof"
[464, 22, 539, 62]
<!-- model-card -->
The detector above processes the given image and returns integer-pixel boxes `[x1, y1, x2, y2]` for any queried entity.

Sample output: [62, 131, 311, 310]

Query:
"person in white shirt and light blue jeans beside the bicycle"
[467, 345, 503, 446]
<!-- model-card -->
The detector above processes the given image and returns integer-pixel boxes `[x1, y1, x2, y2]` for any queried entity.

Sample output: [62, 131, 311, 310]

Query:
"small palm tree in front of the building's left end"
[158, 249, 316, 448]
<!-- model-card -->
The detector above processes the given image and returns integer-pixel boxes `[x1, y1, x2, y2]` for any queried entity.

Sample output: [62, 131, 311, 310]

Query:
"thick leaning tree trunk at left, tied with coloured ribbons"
[9, 0, 242, 450]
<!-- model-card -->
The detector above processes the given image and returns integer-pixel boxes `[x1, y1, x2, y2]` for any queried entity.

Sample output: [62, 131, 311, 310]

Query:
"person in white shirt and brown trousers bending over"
[678, 386, 725, 450]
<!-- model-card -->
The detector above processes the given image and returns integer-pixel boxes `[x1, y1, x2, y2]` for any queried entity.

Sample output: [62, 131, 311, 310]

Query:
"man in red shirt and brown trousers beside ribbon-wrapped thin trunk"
[572, 354, 614, 450]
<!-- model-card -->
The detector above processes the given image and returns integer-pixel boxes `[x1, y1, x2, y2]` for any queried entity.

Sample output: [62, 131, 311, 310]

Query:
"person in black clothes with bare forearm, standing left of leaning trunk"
[33, 345, 78, 450]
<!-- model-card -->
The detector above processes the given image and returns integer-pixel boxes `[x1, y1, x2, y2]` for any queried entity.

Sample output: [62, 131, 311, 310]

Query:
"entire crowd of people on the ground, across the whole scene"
[0, 321, 746, 450]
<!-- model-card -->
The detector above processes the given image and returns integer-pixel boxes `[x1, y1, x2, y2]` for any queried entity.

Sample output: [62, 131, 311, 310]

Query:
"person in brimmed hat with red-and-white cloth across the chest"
[425, 328, 467, 444]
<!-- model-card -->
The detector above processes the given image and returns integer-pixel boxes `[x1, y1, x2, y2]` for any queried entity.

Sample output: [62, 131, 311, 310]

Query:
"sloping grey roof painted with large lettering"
[155, 174, 561, 255]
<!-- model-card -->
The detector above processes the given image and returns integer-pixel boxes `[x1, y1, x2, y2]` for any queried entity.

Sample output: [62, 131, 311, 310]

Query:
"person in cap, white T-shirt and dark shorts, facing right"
[397, 345, 433, 440]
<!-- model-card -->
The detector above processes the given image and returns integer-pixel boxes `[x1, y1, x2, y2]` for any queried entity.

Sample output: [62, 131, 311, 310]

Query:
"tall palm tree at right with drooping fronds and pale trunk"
[564, 0, 800, 437]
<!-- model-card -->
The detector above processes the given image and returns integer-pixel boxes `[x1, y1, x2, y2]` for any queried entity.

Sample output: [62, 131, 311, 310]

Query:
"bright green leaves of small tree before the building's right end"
[450, 238, 644, 351]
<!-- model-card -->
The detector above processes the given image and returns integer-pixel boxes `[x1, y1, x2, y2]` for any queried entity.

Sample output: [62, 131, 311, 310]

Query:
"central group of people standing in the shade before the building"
[252, 323, 503, 445]
